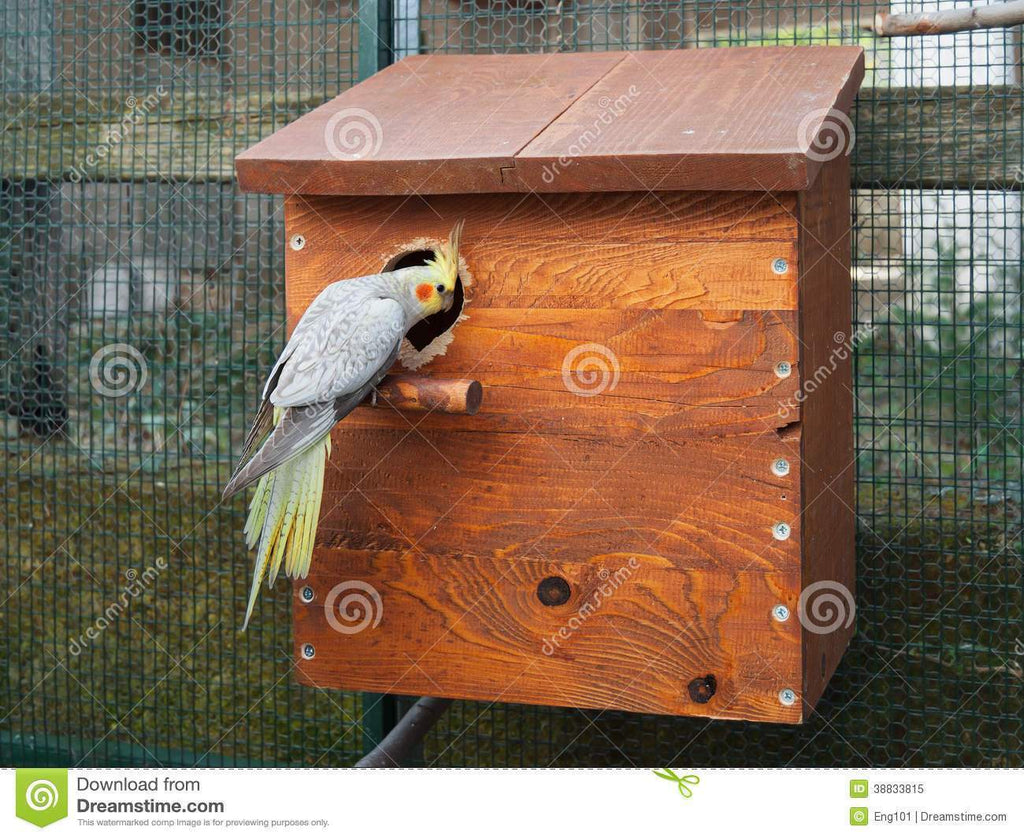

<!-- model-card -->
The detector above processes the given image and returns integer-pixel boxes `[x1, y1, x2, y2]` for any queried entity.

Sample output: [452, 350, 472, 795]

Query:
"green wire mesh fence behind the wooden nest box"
[0, 0, 1024, 765]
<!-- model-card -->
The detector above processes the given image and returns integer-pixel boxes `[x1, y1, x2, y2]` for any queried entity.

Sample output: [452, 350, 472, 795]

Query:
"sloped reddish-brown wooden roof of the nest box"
[236, 46, 864, 195]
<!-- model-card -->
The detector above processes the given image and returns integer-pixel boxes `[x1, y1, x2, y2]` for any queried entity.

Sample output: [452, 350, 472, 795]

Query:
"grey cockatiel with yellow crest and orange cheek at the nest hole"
[224, 221, 462, 631]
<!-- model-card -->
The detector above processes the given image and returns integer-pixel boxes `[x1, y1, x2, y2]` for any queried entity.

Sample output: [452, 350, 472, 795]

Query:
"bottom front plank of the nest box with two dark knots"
[293, 549, 800, 723]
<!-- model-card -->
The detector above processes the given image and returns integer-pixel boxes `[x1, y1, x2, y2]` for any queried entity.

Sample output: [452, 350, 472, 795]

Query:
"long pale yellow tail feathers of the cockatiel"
[242, 436, 331, 631]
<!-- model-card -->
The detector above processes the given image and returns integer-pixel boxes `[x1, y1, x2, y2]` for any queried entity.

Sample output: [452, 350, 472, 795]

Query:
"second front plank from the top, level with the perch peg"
[325, 303, 800, 437]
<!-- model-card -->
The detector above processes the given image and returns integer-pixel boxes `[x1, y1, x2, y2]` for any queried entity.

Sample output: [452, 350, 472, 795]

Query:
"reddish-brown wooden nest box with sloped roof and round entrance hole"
[237, 47, 863, 723]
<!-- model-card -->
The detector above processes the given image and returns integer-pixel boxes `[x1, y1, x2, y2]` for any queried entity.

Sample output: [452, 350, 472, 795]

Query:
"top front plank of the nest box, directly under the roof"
[285, 195, 797, 318]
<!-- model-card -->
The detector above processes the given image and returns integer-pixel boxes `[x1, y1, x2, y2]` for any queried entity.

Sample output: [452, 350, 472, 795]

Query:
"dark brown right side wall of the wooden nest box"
[799, 155, 856, 719]
